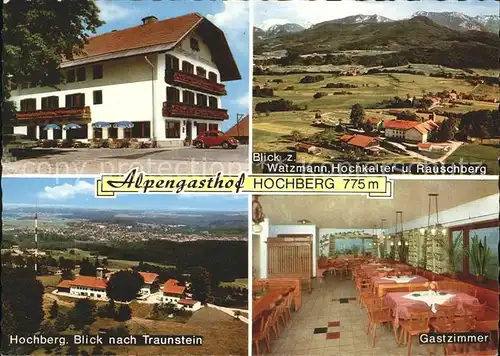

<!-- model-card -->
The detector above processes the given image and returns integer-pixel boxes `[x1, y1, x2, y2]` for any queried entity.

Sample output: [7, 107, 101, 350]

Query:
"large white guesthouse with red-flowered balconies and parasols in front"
[11, 13, 241, 146]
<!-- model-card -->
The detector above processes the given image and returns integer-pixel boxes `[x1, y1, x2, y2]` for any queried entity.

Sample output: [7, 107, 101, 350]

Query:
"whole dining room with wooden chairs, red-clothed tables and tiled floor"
[252, 179, 499, 356]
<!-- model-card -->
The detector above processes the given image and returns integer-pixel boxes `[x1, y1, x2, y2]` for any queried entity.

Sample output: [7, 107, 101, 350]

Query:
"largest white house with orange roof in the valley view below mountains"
[384, 120, 439, 143]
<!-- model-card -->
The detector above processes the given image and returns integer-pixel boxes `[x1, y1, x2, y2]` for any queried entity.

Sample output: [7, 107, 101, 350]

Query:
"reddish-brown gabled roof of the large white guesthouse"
[61, 13, 241, 81]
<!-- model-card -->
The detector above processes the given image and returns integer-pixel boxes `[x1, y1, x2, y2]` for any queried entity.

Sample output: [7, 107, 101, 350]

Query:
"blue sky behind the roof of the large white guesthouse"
[96, 0, 250, 131]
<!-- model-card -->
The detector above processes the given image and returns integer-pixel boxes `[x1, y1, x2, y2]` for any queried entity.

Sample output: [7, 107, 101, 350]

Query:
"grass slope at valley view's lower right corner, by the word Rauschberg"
[446, 143, 500, 174]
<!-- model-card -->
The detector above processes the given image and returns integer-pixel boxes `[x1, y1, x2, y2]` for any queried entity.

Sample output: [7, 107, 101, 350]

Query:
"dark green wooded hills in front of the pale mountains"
[254, 16, 500, 68]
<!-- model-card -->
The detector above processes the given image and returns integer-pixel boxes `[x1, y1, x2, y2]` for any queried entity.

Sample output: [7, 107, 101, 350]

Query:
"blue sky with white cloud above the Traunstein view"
[2, 178, 248, 212]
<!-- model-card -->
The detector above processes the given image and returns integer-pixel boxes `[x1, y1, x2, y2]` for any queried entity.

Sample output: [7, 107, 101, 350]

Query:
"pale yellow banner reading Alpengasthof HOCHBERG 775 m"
[96, 169, 392, 198]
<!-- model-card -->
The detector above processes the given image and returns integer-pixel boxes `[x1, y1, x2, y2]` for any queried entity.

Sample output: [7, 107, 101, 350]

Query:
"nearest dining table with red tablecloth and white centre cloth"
[385, 290, 480, 327]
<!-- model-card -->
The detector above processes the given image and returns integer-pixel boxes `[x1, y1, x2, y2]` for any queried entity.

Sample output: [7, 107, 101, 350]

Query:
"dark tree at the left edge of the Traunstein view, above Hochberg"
[2, 267, 43, 353]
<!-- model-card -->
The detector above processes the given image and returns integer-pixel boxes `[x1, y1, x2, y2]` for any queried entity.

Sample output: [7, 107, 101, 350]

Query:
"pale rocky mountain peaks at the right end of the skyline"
[412, 11, 499, 32]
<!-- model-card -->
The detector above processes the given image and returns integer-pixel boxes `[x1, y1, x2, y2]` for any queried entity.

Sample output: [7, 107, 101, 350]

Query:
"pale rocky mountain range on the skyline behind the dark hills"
[254, 11, 500, 40]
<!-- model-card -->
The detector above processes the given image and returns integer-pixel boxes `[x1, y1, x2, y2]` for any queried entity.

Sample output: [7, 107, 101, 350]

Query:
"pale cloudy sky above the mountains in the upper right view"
[254, 0, 500, 30]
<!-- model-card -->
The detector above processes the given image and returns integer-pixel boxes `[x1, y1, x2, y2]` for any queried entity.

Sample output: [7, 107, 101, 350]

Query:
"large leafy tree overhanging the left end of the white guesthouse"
[2, 0, 104, 128]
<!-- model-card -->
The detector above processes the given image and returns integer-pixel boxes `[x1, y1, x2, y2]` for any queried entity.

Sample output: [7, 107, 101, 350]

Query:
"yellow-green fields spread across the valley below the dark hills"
[253, 73, 500, 171]
